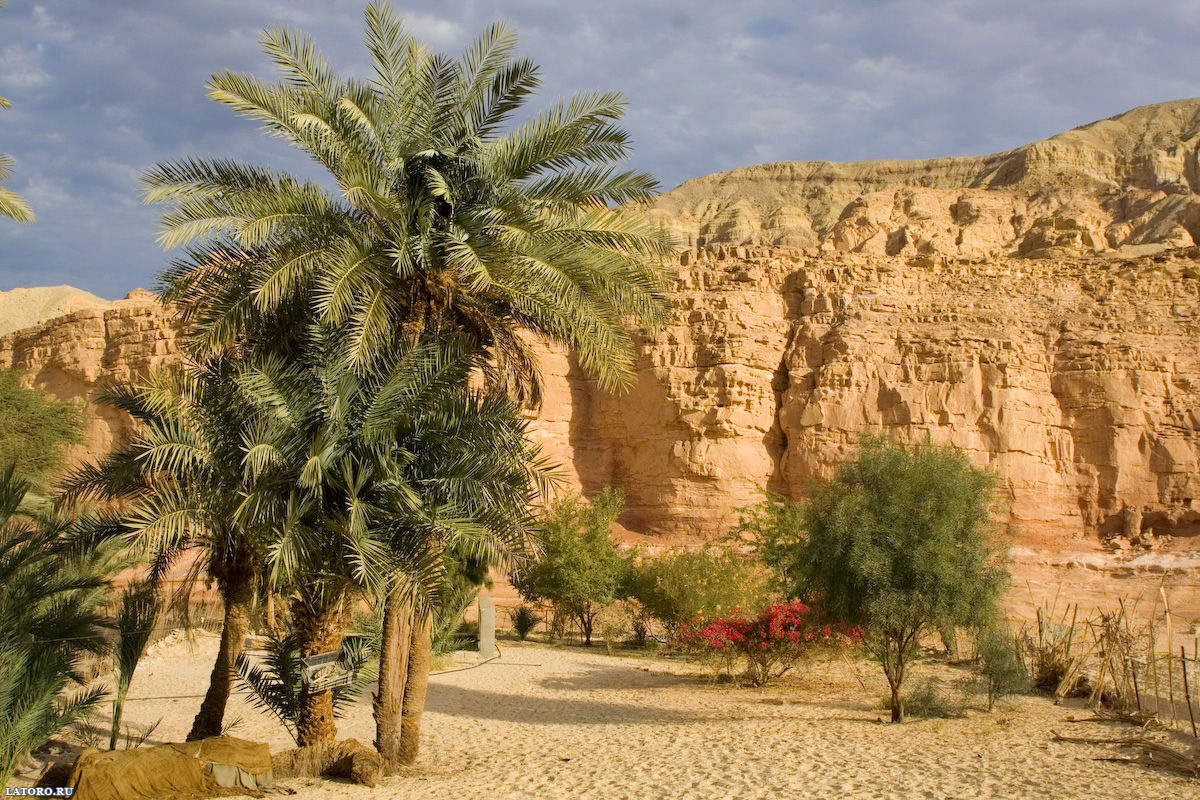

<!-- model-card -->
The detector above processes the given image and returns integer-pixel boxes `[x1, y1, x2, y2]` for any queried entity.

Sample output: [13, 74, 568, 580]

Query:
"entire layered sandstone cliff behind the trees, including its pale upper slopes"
[7, 100, 1200, 563]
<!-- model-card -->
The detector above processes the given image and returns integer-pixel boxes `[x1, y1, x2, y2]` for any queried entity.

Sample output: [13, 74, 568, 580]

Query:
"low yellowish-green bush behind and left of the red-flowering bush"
[625, 547, 770, 633]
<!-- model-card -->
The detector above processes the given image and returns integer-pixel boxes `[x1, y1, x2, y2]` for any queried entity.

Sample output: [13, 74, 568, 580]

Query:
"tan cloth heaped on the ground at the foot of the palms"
[71, 736, 275, 800]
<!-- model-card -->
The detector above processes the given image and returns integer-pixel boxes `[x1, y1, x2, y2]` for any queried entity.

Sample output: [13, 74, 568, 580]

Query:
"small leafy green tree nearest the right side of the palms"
[512, 487, 629, 645]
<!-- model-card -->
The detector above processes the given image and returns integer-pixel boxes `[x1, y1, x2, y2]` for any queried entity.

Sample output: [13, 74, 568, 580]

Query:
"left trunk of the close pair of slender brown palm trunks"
[374, 587, 413, 775]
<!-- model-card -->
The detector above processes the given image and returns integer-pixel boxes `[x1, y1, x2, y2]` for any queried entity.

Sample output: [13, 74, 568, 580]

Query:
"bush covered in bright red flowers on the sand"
[676, 600, 856, 686]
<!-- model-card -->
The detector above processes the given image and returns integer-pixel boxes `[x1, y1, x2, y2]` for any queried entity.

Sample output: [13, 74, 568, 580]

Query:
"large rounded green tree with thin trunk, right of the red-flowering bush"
[766, 438, 1008, 722]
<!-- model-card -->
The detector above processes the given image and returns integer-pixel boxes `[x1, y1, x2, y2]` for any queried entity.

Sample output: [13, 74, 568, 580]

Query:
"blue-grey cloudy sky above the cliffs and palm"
[0, 0, 1200, 297]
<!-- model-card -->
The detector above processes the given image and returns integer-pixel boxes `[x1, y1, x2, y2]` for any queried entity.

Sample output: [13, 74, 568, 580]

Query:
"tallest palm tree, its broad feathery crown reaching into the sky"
[144, 4, 673, 767]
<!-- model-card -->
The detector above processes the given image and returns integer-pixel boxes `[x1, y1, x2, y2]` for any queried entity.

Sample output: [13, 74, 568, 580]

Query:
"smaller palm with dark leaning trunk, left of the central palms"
[62, 359, 269, 740]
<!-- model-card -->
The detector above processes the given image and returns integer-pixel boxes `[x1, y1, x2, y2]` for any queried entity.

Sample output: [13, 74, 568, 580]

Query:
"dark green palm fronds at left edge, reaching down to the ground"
[0, 468, 124, 786]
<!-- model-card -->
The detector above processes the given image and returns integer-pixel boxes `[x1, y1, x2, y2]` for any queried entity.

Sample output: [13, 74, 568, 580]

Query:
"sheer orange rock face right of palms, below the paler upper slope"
[541, 247, 1200, 554]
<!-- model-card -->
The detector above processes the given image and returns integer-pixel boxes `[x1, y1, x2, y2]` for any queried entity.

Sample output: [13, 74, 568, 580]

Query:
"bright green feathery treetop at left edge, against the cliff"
[0, 369, 83, 487]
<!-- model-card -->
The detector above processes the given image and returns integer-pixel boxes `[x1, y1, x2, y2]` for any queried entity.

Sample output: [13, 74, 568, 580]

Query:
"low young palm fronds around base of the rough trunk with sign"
[235, 631, 377, 739]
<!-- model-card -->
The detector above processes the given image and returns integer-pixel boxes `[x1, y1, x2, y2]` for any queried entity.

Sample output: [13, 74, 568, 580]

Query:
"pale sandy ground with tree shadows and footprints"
[44, 633, 1200, 800]
